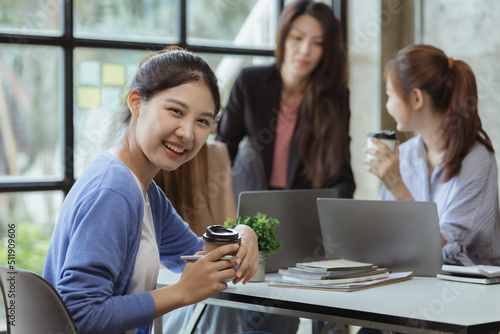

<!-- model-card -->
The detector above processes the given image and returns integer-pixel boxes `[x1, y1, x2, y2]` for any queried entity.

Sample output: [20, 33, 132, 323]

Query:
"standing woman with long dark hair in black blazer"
[216, 0, 355, 198]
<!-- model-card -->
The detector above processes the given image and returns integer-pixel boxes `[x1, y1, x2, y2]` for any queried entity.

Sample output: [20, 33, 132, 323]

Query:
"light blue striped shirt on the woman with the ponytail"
[381, 136, 500, 266]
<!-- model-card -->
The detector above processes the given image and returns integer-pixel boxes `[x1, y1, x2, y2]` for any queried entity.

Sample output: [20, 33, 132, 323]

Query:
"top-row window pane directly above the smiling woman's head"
[74, 0, 179, 44]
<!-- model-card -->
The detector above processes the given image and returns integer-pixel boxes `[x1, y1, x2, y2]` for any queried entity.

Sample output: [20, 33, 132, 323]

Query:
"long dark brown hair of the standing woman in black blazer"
[275, 0, 350, 188]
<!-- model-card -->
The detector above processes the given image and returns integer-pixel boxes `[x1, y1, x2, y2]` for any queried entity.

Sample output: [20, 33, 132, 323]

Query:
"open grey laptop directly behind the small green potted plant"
[238, 189, 337, 273]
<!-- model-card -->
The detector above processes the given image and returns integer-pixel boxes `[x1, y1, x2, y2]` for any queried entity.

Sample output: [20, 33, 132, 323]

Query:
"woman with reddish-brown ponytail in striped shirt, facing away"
[364, 45, 500, 266]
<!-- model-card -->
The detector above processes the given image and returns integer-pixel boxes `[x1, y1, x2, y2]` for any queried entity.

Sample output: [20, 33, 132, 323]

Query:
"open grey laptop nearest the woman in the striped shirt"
[317, 198, 443, 277]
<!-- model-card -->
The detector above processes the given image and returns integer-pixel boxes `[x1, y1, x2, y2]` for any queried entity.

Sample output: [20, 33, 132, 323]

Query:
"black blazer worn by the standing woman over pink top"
[216, 64, 355, 198]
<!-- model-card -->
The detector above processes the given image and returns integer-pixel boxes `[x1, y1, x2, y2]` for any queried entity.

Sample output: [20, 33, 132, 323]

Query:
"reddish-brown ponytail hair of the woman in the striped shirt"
[385, 44, 493, 182]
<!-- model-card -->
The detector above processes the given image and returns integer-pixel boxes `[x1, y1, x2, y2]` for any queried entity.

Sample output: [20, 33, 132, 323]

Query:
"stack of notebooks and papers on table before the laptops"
[269, 259, 412, 291]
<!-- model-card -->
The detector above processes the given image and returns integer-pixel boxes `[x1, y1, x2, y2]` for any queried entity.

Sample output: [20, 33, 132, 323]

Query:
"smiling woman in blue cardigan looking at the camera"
[44, 48, 258, 334]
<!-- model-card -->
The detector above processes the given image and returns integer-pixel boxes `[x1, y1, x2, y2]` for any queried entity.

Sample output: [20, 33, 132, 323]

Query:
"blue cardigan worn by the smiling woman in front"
[43, 152, 203, 334]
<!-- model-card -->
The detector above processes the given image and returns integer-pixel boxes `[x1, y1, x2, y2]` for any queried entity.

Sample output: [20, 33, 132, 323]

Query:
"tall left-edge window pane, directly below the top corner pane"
[0, 44, 63, 182]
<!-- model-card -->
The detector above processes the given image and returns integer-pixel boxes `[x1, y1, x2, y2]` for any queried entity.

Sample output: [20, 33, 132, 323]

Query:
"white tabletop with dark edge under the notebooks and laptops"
[157, 270, 500, 333]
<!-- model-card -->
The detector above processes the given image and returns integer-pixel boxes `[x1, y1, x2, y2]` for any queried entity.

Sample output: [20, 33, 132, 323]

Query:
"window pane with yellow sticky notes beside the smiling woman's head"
[74, 48, 147, 178]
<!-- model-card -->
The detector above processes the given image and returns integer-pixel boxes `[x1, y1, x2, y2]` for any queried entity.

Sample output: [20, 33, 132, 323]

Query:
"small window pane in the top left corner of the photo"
[0, 0, 64, 36]
